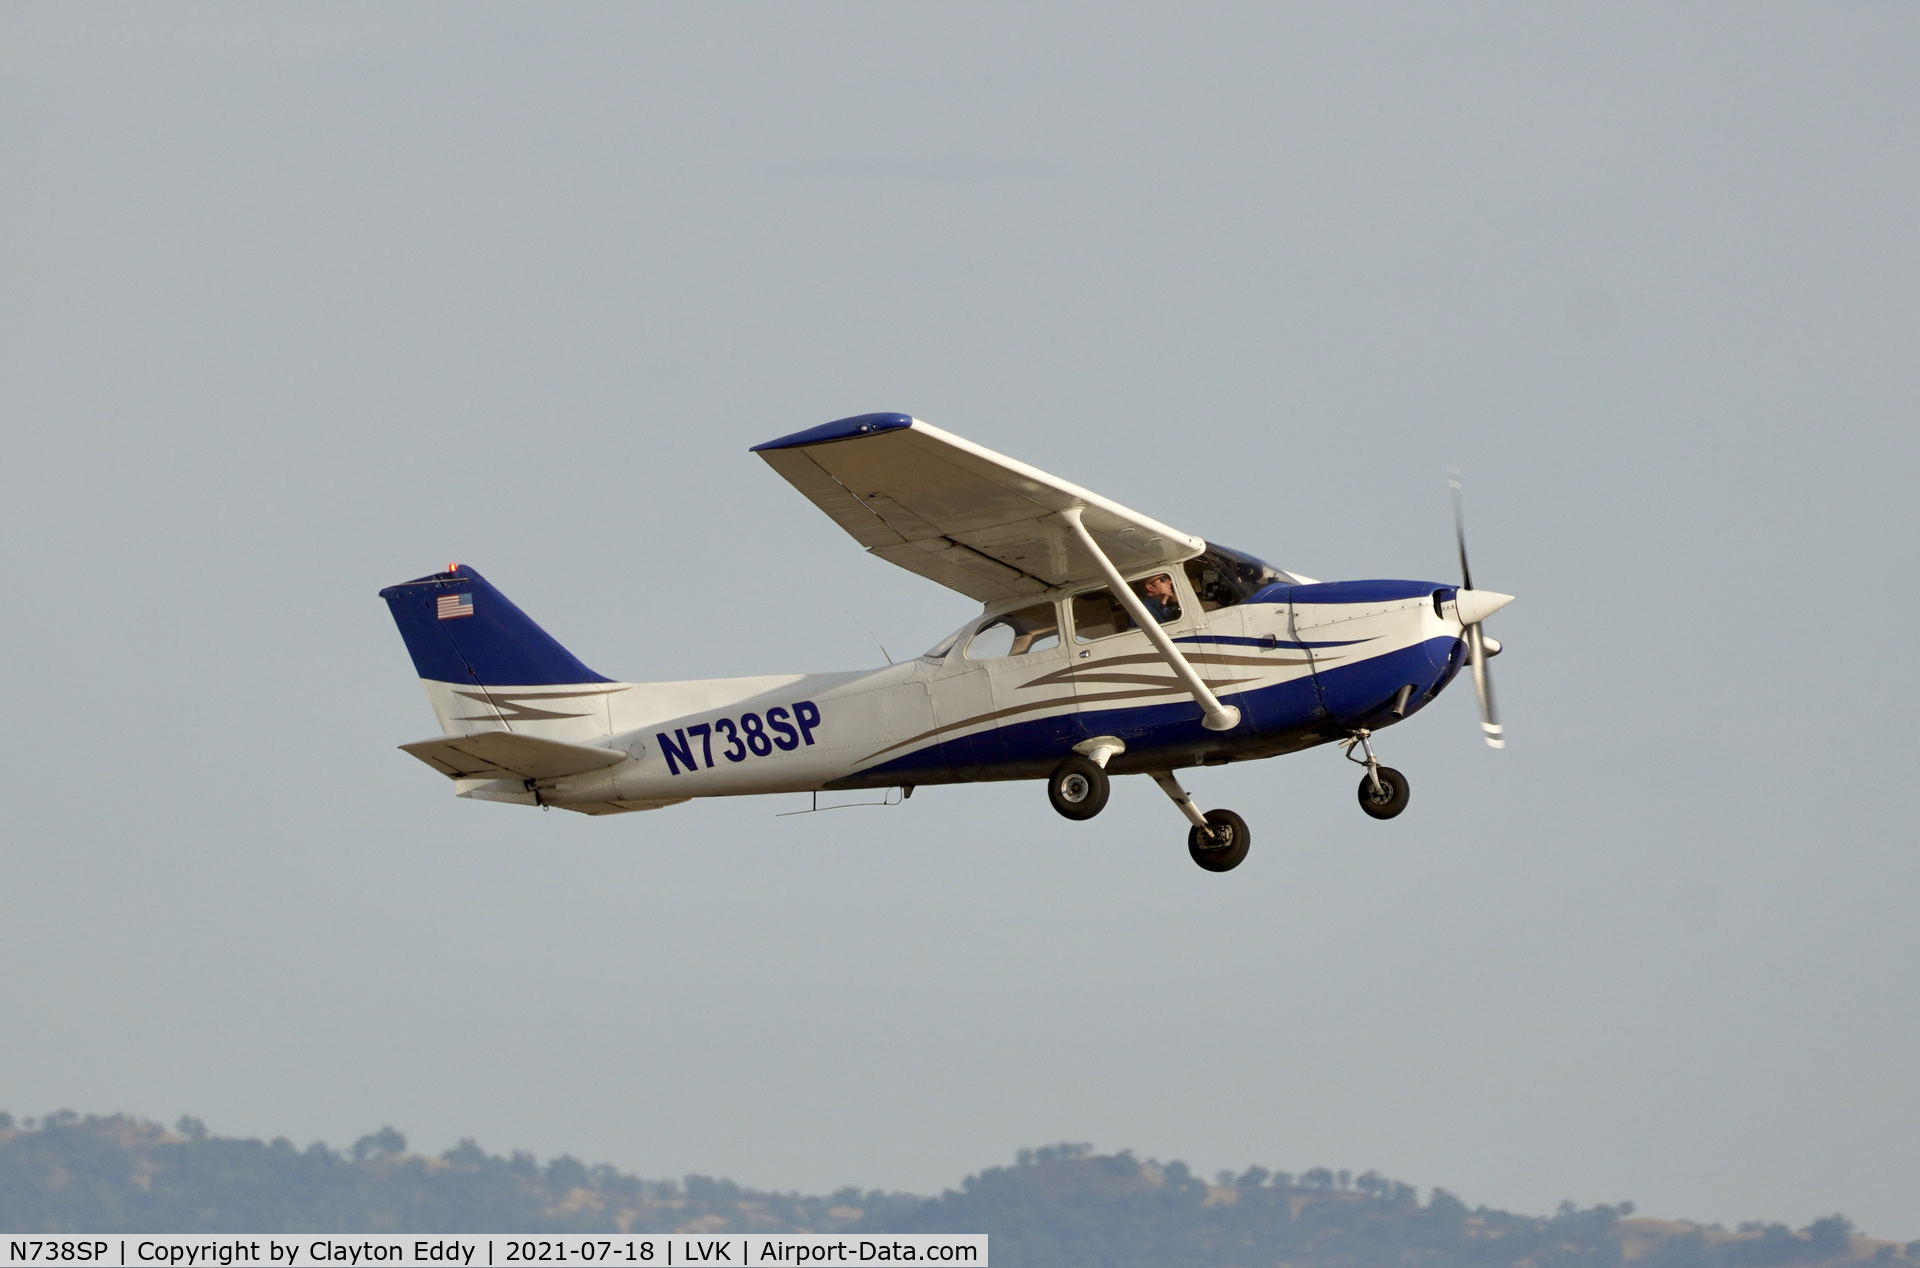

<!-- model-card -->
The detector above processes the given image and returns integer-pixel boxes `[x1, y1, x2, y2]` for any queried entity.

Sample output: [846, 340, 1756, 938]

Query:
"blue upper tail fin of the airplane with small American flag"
[380, 565, 611, 686]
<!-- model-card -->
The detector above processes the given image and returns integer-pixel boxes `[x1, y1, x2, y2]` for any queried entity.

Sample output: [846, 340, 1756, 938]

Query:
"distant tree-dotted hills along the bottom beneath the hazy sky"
[0, 1112, 1920, 1268]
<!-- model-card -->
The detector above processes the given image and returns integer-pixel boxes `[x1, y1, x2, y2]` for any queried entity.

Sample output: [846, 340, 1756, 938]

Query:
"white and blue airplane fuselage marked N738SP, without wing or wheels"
[426, 569, 1461, 813]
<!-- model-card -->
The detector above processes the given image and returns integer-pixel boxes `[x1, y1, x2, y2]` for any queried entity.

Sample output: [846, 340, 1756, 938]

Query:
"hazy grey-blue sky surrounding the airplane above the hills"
[0, 2, 1920, 1237]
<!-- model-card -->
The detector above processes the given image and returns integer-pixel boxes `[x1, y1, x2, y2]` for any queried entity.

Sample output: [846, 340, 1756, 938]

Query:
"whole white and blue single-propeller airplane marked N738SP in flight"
[380, 413, 1513, 872]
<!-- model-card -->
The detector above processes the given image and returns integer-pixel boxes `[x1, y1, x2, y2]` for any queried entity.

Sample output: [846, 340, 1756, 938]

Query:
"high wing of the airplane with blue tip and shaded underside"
[753, 413, 1206, 603]
